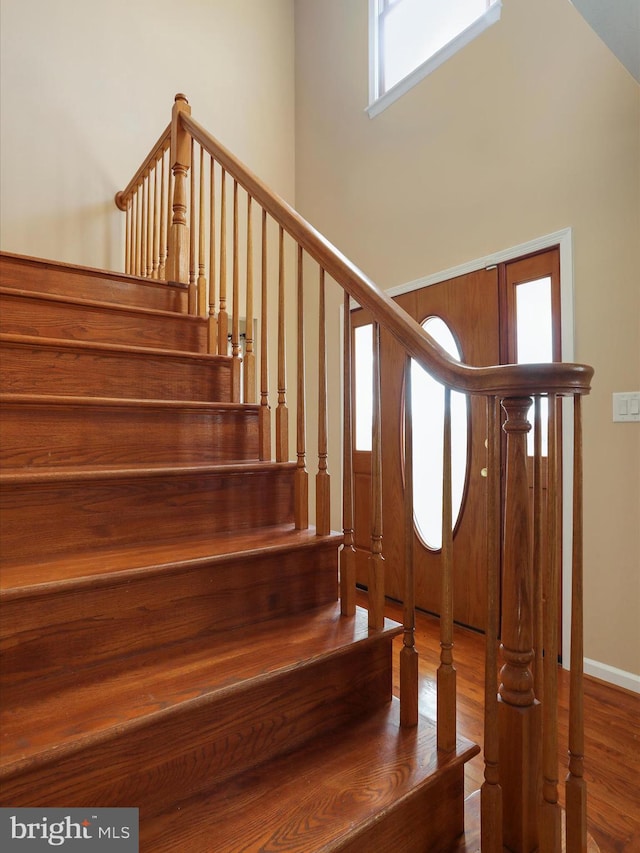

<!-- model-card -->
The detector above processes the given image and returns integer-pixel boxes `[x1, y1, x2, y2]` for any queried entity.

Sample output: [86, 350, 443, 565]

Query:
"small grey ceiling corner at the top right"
[571, 0, 640, 83]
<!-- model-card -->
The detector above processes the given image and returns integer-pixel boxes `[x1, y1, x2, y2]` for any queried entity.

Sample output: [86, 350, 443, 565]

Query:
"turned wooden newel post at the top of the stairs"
[167, 95, 191, 283]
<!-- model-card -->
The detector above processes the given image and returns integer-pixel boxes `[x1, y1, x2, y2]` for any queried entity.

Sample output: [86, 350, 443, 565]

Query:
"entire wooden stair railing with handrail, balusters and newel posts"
[116, 95, 593, 853]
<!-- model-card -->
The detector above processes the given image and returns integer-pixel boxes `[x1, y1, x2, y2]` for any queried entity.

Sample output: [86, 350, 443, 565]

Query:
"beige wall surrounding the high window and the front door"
[295, 0, 640, 674]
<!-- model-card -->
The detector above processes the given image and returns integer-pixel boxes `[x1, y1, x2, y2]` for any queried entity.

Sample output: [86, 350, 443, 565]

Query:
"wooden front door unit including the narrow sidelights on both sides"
[352, 248, 561, 629]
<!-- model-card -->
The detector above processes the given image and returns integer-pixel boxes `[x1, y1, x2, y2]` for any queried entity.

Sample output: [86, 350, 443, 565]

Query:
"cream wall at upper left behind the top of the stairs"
[0, 0, 294, 269]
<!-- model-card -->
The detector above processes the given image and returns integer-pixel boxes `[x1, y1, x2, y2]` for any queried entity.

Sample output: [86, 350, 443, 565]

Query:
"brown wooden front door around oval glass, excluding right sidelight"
[353, 268, 500, 629]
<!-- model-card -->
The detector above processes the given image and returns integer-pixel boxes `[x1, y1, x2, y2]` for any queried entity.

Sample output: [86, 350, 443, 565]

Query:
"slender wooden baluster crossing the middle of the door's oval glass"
[436, 387, 456, 752]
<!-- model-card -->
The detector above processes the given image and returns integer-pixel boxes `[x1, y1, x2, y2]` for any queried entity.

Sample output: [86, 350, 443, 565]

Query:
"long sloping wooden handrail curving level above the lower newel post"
[180, 113, 593, 397]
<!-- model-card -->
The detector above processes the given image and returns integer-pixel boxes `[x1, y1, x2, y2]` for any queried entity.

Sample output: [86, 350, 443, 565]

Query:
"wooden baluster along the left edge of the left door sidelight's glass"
[340, 291, 356, 616]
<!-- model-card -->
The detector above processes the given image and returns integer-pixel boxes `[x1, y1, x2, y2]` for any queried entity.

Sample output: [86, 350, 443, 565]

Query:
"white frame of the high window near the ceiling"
[366, 0, 502, 118]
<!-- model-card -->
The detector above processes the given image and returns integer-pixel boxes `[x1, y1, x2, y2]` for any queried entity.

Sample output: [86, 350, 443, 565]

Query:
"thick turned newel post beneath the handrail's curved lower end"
[499, 397, 541, 853]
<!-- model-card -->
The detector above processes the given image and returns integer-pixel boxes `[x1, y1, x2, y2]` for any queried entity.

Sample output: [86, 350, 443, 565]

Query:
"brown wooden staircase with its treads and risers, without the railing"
[0, 254, 478, 853]
